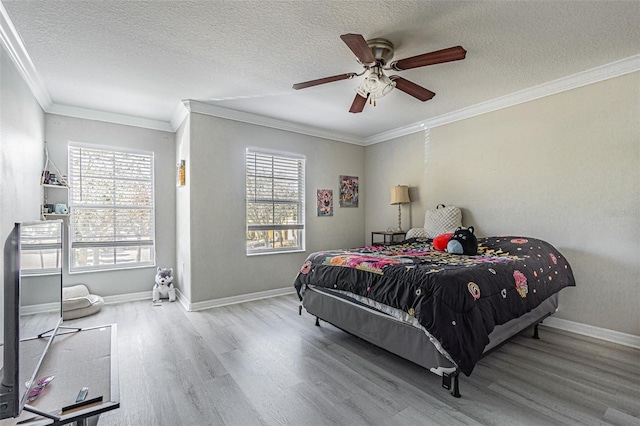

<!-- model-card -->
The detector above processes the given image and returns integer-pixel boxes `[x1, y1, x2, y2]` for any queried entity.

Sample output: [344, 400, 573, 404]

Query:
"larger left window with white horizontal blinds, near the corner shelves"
[69, 143, 155, 272]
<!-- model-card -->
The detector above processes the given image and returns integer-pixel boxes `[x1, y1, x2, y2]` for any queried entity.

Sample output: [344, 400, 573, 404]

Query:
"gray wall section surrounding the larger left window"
[44, 114, 176, 296]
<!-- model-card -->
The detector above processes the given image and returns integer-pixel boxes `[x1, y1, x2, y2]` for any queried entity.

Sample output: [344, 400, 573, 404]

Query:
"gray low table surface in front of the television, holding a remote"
[0, 324, 120, 426]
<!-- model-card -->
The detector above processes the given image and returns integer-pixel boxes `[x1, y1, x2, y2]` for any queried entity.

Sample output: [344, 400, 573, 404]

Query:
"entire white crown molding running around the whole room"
[0, 2, 640, 146]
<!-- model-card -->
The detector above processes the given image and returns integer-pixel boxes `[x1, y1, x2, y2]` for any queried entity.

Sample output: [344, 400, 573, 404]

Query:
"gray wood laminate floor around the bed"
[15, 295, 640, 426]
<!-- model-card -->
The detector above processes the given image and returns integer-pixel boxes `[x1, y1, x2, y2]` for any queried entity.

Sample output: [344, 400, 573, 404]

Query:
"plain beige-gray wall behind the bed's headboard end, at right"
[365, 73, 640, 335]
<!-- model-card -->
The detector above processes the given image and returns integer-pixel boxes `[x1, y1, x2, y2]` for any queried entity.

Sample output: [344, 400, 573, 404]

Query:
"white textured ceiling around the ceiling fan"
[2, 0, 640, 138]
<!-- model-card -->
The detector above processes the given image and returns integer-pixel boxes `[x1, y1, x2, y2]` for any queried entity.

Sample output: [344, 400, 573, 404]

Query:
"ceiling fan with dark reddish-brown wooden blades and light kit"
[293, 34, 467, 113]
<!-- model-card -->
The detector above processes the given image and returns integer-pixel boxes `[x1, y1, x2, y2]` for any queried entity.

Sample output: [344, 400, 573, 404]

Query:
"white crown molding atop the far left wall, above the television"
[0, 2, 53, 111]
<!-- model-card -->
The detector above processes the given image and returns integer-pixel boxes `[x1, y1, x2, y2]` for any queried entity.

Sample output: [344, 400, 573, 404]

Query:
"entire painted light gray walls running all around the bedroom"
[0, 38, 640, 335]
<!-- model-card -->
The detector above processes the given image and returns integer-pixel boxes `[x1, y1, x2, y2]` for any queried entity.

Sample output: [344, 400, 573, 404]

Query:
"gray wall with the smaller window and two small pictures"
[184, 113, 366, 303]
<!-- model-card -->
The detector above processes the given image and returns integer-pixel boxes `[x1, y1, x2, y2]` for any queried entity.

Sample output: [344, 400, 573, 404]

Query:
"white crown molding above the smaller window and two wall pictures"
[182, 99, 364, 145]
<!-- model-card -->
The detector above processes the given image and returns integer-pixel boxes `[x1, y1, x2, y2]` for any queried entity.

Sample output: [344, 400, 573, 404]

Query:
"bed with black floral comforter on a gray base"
[294, 236, 575, 397]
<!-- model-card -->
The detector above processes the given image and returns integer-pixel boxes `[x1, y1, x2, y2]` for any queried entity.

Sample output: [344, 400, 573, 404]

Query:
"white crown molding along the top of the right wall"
[364, 55, 640, 146]
